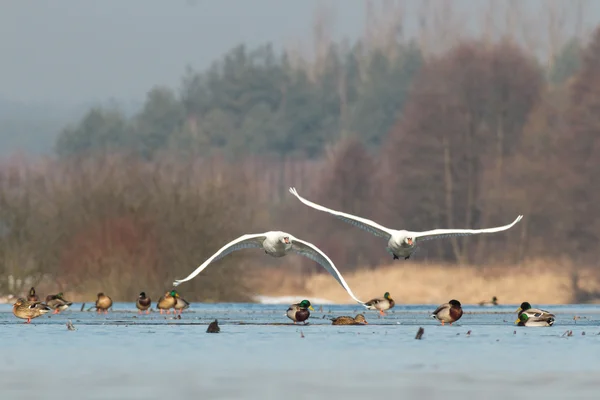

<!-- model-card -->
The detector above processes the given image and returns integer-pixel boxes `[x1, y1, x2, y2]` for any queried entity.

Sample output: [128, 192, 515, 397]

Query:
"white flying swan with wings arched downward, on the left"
[173, 231, 365, 305]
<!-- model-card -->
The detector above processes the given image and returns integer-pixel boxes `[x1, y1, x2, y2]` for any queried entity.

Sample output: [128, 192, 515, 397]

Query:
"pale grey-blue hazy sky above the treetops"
[0, 0, 600, 104]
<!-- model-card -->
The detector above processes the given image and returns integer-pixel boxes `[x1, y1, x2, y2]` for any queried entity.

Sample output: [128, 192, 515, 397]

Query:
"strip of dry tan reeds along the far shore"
[247, 262, 600, 304]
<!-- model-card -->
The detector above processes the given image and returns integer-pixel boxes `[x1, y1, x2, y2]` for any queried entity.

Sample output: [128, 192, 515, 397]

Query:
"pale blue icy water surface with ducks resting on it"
[0, 303, 600, 400]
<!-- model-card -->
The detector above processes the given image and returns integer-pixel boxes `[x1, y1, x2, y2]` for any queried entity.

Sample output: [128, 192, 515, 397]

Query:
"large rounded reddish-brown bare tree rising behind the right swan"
[381, 42, 543, 263]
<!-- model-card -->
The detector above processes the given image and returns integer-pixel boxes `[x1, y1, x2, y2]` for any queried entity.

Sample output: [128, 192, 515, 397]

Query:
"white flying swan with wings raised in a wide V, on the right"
[290, 188, 523, 260]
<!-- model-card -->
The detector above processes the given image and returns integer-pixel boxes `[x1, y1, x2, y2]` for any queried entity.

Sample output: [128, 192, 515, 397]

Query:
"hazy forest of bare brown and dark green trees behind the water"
[0, 2, 600, 301]
